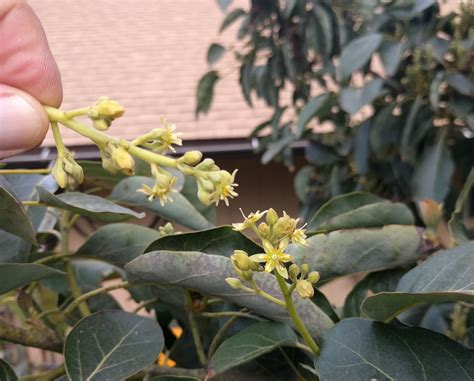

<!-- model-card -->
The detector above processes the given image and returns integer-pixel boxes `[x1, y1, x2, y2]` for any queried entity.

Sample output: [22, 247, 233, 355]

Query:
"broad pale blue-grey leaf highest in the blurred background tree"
[341, 33, 383, 80]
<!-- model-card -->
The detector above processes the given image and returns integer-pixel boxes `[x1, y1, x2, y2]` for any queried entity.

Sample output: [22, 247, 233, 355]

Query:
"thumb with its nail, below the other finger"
[0, 84, 49, 159]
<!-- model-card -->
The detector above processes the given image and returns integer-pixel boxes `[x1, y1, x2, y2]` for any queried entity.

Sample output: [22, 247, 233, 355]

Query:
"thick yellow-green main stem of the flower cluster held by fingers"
[44, 106, 177, 168]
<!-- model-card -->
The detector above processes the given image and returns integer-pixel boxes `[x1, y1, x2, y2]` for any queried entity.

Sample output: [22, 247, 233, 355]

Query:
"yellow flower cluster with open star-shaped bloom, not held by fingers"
[226, 209, 319, 298]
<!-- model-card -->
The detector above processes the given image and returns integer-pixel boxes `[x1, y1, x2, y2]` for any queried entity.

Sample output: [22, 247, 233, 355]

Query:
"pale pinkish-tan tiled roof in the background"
[29, 0, 270, 146]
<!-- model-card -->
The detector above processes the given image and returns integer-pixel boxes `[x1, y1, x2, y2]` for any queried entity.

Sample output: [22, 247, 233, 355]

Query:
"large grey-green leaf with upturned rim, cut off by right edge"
[362, 241, 474, 321]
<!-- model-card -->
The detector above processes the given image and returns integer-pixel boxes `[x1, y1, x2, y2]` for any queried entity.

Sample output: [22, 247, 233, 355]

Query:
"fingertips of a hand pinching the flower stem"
[0, 0, 63, 159]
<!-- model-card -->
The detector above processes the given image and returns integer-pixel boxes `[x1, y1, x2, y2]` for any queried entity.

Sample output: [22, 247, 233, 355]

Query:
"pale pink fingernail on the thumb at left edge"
[0, 94, 43, 157]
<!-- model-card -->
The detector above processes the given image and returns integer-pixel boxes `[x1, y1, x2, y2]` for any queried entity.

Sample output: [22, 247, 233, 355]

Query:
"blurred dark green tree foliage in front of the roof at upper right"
[196, 0, 474, 217]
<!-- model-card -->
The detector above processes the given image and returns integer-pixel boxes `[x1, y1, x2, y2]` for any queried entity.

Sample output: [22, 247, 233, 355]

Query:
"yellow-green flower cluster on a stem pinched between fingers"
[49, 97, 237, 206]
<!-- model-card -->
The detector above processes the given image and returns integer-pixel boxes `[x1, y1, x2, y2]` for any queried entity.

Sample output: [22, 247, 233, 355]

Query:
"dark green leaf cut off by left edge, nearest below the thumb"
[0, 187, 36, 243]
